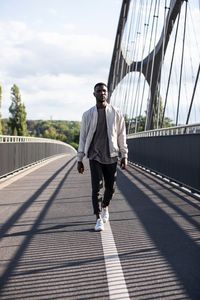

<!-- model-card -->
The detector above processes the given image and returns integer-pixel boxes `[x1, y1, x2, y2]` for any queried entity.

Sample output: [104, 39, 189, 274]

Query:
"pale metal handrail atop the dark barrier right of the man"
[127, 123, 200, 139]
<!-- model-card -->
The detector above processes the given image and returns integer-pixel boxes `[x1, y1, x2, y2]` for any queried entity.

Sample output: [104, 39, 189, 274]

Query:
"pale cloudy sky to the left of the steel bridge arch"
[0, 0, 122, 121]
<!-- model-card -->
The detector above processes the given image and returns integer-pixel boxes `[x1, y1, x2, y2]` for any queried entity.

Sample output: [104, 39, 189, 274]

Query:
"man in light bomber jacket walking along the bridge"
[77, 82, 128, 231]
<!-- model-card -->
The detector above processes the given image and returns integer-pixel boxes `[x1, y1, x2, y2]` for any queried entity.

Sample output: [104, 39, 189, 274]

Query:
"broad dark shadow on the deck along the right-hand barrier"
[117, 169, 200, 299]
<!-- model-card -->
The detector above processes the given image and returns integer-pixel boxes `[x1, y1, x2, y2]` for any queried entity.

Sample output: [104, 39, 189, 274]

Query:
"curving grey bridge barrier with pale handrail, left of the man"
[0, 136, 76, 177]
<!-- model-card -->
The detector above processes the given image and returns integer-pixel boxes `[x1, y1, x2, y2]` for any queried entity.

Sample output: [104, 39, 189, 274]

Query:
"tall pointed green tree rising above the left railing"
[9, 84, 28, 136]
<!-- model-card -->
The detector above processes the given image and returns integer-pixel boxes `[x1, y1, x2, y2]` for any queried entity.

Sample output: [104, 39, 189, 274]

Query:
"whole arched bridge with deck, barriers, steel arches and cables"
[0, 0, 200, 300]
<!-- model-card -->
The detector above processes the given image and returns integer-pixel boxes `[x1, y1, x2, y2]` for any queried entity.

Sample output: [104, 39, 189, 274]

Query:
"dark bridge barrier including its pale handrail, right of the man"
[127, 124, 200, 193]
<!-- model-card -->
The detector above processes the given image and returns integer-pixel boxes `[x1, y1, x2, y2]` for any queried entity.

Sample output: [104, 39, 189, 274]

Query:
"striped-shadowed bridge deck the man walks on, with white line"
[0, 156, 200, 300]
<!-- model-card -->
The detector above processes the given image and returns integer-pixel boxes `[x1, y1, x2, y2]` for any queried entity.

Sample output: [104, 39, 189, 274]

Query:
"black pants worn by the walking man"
[90, 160, 117, 215]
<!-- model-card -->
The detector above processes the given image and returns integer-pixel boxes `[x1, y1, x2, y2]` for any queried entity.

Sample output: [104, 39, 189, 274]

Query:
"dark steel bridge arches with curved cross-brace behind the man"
[108, 0, 183, 130]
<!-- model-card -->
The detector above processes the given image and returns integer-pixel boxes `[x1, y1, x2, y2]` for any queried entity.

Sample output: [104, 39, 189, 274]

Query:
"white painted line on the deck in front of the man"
[101, 222, 130, 300]
